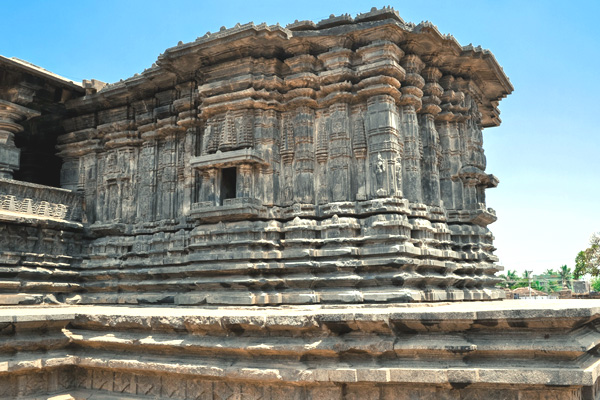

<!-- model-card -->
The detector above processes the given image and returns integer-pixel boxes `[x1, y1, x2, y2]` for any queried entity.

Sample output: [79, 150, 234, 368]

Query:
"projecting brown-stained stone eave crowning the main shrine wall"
[69, 8, 513, 127]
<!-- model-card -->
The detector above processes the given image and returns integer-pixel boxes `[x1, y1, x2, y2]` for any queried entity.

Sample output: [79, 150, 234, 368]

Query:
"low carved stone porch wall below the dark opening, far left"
[0, 179, 87, 304]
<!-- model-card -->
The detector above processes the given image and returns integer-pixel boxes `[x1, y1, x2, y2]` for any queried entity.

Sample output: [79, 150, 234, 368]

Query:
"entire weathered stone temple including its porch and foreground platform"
[0, 7, 600, 400]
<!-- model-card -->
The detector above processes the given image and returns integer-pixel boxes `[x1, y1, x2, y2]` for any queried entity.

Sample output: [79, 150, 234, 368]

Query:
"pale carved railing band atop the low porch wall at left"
[0, 179, 82, 222]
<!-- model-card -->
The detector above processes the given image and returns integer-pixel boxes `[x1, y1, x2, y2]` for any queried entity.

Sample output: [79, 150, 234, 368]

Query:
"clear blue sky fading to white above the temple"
[0, 0, 600, 273]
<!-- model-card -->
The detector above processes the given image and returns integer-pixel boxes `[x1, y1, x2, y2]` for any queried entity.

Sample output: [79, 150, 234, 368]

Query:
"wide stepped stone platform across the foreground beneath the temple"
[0, 300, 600, 400]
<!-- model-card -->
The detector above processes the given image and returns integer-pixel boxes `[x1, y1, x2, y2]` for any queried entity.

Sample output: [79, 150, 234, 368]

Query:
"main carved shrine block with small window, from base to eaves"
[50, 9, 512, 305]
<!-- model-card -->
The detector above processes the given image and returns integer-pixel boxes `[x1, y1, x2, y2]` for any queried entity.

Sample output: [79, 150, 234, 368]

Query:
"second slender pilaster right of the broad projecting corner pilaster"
[420, 67, 444, 207]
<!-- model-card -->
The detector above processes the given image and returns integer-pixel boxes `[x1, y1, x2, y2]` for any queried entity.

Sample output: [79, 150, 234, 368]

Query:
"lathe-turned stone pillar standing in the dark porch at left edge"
[0, 100, 40, 179]
